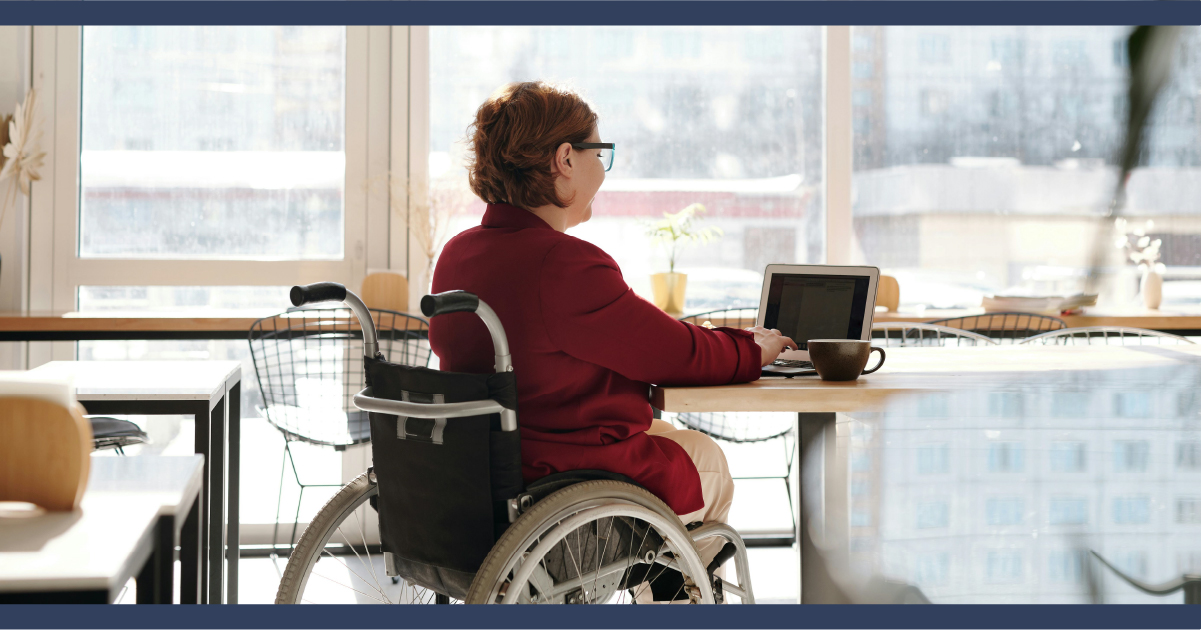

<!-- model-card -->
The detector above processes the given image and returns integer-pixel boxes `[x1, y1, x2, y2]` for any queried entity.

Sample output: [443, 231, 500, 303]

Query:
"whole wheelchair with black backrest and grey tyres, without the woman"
[276, 282, 754, 604]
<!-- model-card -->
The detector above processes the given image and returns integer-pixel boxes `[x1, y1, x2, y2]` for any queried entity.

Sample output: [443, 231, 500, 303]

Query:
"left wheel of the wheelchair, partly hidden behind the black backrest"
[275, 473, 449, 604]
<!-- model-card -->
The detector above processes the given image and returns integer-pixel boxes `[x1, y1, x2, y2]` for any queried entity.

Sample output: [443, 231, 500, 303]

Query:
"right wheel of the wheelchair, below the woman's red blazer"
[466, 480, 713, 604]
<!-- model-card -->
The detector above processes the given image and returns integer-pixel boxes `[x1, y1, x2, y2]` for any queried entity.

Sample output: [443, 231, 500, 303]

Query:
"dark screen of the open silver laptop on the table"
[763, 274, 871, 350]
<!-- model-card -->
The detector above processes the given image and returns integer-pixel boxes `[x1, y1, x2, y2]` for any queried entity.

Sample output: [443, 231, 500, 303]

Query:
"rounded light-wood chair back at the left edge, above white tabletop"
[0, 396, 92, 511]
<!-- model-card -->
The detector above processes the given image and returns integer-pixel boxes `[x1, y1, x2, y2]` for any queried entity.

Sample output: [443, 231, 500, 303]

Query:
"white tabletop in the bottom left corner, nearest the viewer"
[0, 455, 203, 593]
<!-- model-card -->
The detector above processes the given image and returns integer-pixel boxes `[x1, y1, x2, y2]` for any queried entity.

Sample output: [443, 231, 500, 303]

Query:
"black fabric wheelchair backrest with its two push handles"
[291, 282, 522, 599]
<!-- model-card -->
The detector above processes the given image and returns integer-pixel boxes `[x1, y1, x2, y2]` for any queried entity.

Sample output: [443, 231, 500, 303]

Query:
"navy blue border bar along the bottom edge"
[0, 605, 1201, 629]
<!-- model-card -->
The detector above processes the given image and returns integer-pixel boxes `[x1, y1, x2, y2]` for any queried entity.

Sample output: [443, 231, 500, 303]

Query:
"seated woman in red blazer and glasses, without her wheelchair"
[430, 83, 795, 595]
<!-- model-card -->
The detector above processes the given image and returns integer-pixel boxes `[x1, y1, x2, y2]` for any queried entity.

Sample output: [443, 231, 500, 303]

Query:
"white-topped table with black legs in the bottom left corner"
[0, 455, 204, 604]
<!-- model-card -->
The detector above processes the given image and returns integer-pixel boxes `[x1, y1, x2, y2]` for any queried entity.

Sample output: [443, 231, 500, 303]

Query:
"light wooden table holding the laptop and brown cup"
[651, 346, 1201, 604]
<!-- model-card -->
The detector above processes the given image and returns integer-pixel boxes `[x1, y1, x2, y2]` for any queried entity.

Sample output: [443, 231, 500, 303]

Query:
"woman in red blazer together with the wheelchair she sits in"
[277, 83, 795, 604]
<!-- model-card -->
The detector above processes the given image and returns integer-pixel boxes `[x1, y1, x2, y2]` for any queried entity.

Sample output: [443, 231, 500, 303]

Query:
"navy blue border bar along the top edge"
[0, 0, 1201, 25]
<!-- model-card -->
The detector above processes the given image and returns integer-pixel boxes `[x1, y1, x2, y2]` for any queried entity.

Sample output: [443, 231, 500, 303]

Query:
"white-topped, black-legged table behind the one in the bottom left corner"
[30, 361, 241, 604]
